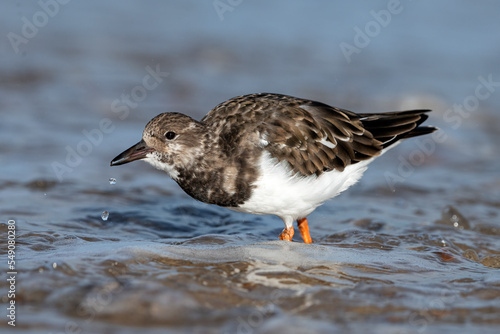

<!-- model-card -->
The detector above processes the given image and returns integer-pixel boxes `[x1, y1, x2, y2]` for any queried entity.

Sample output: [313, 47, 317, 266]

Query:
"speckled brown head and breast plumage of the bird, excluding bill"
[139, 113, 258, 207]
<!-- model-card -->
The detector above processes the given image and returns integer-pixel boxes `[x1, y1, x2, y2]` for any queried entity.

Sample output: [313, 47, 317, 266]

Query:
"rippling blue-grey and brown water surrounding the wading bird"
[0, 1, 500, 334]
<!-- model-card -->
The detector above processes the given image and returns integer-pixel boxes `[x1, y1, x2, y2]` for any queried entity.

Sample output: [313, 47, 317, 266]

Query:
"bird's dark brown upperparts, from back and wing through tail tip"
[202, 93, 436, 176]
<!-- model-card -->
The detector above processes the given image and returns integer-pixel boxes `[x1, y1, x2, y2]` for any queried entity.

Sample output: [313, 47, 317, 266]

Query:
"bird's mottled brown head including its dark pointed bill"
[111, 113, 208, 179]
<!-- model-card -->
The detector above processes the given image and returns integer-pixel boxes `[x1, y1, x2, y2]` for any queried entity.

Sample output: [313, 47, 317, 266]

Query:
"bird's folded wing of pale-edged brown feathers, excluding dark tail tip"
[262, 100, 383, 175]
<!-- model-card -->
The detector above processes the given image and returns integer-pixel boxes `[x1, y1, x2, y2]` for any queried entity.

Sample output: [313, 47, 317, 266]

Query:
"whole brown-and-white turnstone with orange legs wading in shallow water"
[111, 93, 436, 243]
